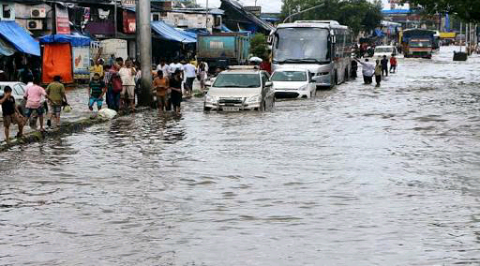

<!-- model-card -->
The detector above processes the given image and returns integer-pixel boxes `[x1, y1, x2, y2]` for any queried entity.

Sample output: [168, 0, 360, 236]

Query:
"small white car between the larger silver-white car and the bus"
[271, 69, 317, 99]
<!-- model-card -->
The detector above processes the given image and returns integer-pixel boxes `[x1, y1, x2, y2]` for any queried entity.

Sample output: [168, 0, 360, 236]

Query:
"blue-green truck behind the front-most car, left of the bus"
[197, 33, 250, 73]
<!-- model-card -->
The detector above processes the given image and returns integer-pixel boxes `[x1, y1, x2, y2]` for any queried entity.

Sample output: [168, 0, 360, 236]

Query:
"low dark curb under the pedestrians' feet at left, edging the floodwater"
[0, 107, 151, 153]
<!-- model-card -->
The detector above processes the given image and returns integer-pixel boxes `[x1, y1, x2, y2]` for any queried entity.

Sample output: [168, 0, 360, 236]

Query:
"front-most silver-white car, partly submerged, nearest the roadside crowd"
[204, 67, 275, 112]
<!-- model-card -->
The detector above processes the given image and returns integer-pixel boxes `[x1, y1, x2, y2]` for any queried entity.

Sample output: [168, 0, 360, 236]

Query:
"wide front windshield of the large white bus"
[273, 28, 330, 63]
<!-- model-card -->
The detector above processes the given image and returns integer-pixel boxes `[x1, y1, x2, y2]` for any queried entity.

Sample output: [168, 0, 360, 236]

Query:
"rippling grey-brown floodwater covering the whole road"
[0, 47, 480, 266]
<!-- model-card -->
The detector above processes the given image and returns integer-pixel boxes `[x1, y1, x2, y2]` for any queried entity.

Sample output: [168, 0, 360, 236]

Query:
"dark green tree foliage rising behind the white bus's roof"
[282, 0, 383, 33]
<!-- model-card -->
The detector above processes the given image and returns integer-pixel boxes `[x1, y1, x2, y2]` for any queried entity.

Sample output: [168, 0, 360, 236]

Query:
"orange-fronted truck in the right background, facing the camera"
[402, 29, 439, 58]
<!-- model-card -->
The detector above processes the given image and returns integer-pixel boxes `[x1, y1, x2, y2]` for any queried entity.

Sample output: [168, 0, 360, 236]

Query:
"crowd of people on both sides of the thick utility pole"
[89, 57, 208, 114]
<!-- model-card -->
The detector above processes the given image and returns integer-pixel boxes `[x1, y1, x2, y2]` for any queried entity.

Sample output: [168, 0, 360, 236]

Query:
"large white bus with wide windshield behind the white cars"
[269, 20, 353, 88]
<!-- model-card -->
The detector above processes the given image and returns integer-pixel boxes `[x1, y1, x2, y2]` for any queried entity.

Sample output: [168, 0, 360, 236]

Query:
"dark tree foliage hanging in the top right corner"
[408, 0, 480, 22]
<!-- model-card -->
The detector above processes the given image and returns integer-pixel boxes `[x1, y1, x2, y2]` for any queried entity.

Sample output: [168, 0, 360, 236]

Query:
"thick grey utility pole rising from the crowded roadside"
[136, 0, 152, 106]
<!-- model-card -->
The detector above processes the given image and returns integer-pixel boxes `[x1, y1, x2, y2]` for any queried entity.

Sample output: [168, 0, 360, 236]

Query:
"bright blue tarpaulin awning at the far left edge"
[0, 21, 40, 56]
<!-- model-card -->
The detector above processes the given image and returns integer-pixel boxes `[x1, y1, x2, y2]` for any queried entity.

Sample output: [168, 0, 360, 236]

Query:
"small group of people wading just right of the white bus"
[354, 54, 398, 87]
